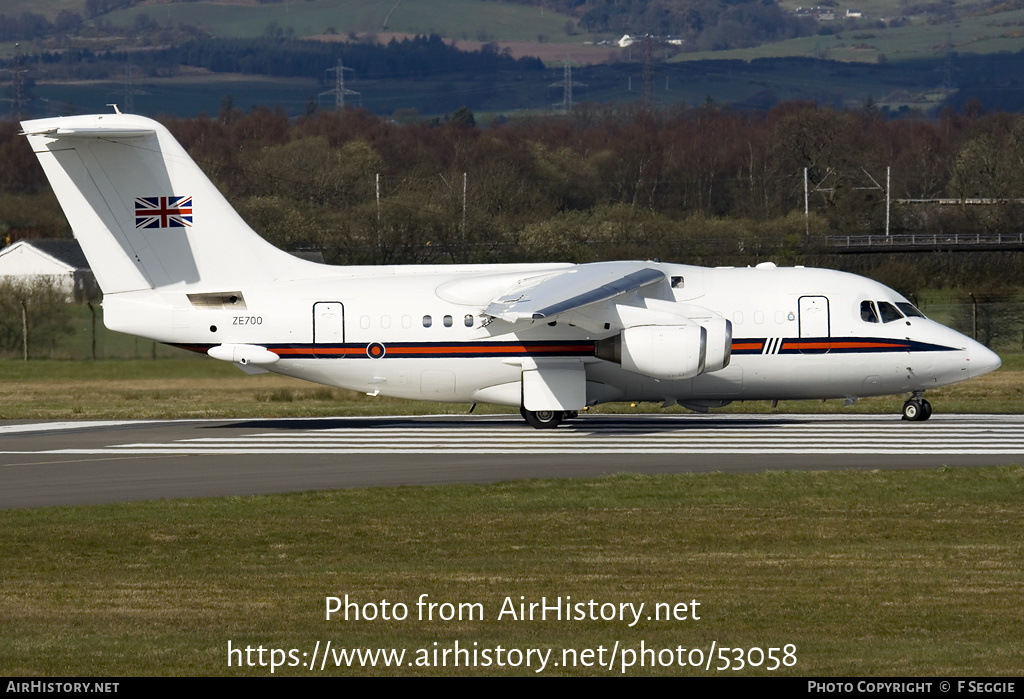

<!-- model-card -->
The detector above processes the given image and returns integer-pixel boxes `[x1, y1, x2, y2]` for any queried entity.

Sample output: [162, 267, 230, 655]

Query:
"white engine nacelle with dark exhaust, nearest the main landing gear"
[596, 323, 708, 381]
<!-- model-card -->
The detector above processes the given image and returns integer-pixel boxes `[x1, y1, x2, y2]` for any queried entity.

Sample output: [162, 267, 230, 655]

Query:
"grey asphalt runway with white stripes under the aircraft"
[0, 414, 1024, 509]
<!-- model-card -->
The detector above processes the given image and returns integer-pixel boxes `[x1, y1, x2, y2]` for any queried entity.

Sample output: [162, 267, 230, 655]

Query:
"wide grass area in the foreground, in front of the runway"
[0, 466, 1024, 676]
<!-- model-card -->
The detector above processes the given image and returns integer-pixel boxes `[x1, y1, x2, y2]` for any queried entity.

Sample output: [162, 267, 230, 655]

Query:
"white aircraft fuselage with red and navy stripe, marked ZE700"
[105, 263, 998, 408]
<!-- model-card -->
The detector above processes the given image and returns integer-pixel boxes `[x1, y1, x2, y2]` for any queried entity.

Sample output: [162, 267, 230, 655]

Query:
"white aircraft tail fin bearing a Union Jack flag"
[22, 114, 302, 294]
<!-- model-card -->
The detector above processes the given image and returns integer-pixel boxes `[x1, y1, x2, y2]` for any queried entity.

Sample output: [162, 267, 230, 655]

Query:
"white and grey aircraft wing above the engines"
[483, 262, 668, 322]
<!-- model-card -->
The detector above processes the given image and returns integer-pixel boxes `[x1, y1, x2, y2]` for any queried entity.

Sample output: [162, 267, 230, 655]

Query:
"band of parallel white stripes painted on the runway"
[25, 417, 1024, 455]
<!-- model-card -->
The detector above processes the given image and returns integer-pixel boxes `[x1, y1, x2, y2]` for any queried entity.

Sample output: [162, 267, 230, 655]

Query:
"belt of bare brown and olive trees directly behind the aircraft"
[0, 101, 1024, 289]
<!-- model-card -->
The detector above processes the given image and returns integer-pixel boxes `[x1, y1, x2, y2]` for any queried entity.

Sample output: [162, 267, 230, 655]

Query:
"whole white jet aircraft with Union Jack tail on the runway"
[23, 114, 1000, 428]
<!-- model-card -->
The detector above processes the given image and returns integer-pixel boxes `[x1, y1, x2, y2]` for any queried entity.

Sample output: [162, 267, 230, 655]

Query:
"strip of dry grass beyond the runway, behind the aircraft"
[0, 354, 1024, 420]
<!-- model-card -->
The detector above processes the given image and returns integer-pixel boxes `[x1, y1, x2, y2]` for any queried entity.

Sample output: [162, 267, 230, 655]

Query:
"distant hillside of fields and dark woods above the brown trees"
[6, 0, 1024, 118]
